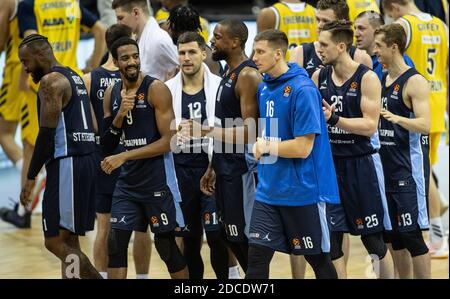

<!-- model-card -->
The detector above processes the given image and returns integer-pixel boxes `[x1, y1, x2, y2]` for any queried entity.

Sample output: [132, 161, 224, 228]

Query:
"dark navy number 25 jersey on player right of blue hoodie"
[319, 64, 380, 158]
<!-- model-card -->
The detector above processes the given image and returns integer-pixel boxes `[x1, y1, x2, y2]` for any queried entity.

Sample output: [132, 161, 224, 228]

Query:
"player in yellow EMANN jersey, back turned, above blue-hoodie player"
[257, 0, 317, 59]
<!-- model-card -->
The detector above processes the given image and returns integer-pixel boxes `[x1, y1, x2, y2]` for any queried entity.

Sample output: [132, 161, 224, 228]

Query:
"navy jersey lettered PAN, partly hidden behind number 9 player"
[89, 66, 121, 136]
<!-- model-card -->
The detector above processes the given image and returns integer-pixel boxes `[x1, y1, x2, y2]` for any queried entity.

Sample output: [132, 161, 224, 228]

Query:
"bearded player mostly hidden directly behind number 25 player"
[290, 0, 372, 77]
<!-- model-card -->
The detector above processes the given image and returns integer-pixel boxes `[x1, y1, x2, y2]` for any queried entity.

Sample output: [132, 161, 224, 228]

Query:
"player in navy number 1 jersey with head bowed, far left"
[19, 34, 101, 278]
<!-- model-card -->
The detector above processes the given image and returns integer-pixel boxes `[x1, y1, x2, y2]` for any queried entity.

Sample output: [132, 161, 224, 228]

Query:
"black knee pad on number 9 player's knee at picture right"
[155, 232, 186, 273]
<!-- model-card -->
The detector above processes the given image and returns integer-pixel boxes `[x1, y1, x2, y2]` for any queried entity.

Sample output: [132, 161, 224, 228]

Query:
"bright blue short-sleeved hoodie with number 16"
[256, 63, 339, 206]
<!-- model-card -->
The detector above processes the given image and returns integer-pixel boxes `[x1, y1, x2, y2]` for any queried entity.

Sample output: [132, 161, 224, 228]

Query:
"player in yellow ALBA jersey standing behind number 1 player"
[5, 0, 105, 227]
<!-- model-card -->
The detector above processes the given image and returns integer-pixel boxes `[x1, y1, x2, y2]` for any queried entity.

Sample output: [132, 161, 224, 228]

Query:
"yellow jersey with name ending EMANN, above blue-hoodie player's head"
[271, 2, 318, 52]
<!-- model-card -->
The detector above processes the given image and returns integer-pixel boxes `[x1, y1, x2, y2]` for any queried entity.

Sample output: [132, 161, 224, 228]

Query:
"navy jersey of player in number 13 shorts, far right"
[379, 68, 428, 192]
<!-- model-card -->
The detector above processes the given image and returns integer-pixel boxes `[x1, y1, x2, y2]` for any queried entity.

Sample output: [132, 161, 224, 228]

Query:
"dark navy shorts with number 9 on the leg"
[111, 187, 178, 234]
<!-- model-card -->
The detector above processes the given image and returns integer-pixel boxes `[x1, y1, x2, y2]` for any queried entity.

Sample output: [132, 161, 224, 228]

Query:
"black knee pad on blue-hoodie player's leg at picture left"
[245, 245, 275, 279]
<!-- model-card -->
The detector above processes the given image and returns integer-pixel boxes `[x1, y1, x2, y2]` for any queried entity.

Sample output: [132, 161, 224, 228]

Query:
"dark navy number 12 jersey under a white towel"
[173, 89, 209, 168]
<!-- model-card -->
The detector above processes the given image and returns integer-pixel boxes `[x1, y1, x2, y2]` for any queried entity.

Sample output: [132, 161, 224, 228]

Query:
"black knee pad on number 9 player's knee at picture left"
[108, 228, 131, 268]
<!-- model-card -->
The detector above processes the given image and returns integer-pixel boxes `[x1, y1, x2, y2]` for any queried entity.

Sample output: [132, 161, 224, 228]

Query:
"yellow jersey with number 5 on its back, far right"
[400, 13, 448, 133]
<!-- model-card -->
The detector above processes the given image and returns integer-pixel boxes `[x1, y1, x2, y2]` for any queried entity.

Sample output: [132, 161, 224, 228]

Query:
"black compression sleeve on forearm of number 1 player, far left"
[27, 127, 56, 180]
